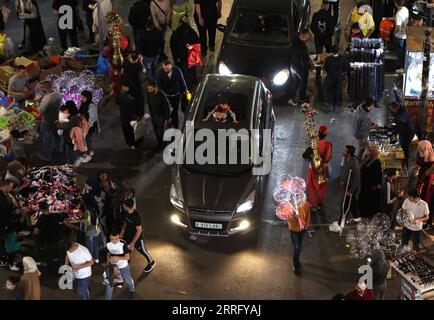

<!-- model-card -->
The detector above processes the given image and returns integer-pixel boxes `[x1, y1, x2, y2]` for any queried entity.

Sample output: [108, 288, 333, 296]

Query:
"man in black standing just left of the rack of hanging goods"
[324, 45, 349, 110]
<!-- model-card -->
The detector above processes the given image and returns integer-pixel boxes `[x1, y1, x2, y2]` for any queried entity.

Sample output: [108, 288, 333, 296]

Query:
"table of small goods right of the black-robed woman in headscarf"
[368, 127, 408, 177]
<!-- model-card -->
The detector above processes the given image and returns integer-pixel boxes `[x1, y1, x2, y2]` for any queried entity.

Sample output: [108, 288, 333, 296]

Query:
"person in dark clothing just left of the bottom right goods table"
[370, 250, 390, 300]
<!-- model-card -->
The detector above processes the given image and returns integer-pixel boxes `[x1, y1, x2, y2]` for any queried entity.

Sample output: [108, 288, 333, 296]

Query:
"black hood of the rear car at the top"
[217, 42, 289, 80]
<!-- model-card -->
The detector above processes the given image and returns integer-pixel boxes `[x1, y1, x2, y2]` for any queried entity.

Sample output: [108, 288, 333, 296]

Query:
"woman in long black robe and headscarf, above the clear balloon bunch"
[359, 145, 383, 218]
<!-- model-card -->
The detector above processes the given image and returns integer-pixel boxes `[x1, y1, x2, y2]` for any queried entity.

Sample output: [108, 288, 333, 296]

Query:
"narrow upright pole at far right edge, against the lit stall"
[419, 0, 433, 136]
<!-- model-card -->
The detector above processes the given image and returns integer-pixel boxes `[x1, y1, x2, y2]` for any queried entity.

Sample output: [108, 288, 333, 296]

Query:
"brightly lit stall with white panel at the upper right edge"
[403, 26, 434, 132]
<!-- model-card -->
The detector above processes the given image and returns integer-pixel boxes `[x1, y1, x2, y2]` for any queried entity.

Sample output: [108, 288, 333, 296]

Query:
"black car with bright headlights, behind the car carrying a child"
[216, 0, 310, 97]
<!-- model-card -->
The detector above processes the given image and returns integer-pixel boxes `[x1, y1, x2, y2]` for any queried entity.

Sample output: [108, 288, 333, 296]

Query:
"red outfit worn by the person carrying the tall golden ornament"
[307, 140, 332, 207]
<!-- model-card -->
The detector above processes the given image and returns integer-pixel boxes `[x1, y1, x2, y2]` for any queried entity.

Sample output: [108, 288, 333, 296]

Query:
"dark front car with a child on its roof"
[169, 74, 275, 236]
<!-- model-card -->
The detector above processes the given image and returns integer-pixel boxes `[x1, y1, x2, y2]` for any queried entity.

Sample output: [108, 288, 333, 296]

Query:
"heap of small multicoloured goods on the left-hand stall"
[23, 165, 83, 222]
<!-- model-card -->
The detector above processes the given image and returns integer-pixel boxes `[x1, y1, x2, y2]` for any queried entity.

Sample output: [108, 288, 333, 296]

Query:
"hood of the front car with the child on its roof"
[180, 170, 254, 211]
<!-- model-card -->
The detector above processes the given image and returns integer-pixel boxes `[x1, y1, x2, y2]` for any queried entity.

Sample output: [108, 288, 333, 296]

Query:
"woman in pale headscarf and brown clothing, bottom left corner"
[20, 257, 41, 300]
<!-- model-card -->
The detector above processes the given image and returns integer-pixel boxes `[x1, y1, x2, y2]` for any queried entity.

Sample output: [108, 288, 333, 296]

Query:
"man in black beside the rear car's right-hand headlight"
[288, 29, 313, 106]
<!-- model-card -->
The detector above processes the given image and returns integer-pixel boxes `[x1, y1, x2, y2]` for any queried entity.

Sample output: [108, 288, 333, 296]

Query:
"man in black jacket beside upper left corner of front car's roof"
[157, 61, 188, 129]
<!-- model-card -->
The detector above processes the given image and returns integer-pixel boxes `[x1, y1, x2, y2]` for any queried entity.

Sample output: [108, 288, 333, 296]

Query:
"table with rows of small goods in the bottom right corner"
[391, 252, 434, 300]
